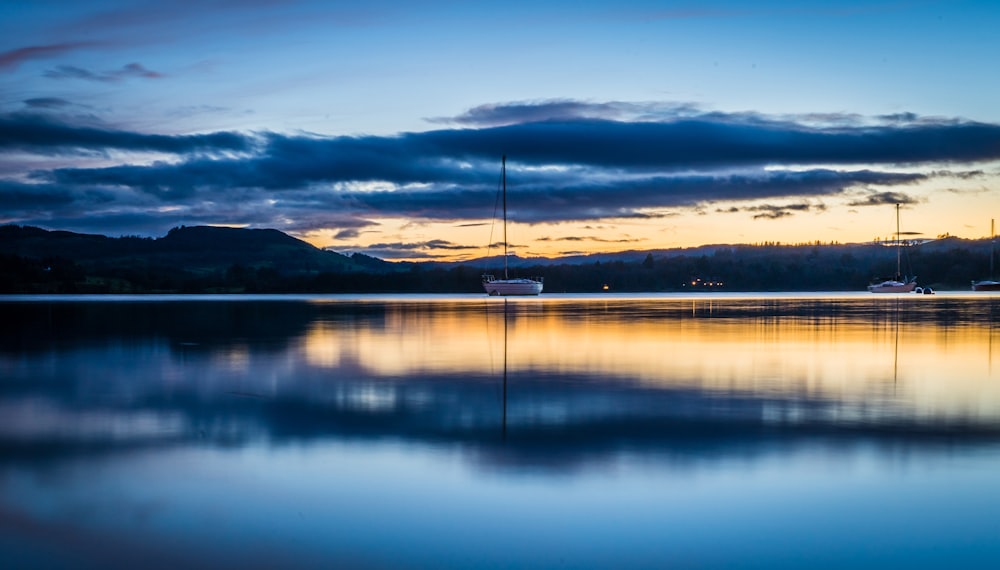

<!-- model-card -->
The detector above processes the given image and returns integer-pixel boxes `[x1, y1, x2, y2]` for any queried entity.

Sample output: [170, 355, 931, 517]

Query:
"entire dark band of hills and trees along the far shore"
[0, 226, 990, 293]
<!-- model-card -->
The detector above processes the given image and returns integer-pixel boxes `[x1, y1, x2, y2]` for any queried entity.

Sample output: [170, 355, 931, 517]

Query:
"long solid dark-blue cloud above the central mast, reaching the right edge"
[411, 117, 1000, 170]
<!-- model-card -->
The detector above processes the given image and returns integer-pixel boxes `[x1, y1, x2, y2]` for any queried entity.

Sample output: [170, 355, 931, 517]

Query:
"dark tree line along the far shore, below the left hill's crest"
[0, 239, 991, 293]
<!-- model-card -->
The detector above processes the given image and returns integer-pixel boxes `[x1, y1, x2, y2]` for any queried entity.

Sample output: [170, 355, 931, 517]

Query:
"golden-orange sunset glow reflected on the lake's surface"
[302, 303, 1000, 417]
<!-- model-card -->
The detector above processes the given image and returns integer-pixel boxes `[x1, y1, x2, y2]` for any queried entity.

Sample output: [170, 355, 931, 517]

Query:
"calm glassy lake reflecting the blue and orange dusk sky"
[0, 293, 1000, 569]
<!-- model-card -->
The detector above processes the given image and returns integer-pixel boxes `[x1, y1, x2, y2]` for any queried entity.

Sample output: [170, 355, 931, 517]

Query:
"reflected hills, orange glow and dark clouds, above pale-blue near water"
[0, 299, 1000, 464]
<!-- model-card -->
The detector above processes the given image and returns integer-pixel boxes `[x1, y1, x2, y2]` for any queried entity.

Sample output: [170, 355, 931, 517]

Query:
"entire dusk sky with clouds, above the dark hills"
[0, 0, 1000, 260]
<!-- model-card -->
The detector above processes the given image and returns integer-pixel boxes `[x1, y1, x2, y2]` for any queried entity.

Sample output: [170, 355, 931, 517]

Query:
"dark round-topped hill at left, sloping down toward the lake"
[0, 225, 368, 292]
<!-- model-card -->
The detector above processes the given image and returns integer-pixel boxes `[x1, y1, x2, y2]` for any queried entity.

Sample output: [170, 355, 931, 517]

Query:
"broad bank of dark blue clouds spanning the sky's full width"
[0, 100, 1000, 235]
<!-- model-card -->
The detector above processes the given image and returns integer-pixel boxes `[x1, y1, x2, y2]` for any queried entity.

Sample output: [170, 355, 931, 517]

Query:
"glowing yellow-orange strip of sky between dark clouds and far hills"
[299, 176, 1000, 261]
